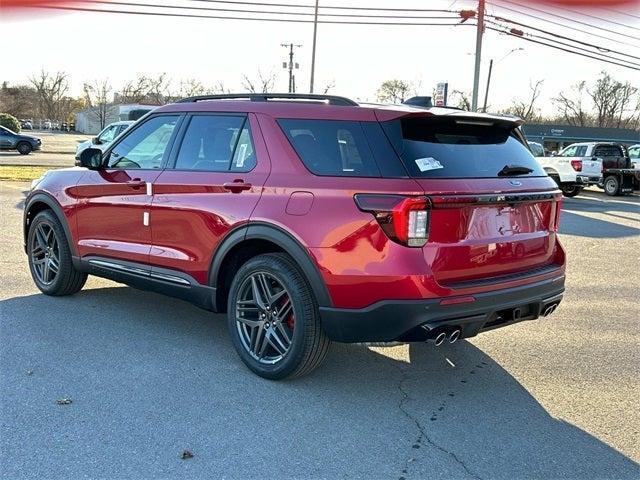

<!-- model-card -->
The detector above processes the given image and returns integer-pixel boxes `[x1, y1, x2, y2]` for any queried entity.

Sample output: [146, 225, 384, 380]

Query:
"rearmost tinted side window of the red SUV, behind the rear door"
[278, 119, 406, 177]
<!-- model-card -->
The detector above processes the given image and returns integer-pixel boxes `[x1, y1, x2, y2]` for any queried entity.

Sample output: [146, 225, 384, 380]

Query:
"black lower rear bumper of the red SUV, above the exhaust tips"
[320, 274, 565, 343]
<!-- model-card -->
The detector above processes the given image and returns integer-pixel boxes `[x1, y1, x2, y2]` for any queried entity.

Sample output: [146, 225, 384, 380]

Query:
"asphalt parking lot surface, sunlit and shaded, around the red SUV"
[0, 182, 640, 480]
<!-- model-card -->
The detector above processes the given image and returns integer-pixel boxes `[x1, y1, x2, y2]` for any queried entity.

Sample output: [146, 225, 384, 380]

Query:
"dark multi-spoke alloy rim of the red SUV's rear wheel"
[235, 272, 295, 365]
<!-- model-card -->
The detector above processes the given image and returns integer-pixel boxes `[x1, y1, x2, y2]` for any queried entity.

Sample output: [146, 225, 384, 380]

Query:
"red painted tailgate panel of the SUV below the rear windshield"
[416, 180, 561, 287]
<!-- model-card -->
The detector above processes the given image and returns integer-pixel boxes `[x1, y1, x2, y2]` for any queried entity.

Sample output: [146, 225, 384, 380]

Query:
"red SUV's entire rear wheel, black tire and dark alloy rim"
[227, 253, 329, 380]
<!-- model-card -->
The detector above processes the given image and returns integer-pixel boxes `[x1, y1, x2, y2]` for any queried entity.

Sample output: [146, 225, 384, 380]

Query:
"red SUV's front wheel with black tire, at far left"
[27, 210, 87, 296]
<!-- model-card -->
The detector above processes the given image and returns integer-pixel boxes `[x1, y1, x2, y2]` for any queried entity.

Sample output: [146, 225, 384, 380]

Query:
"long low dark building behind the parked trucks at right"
[522, 123, 640, 152]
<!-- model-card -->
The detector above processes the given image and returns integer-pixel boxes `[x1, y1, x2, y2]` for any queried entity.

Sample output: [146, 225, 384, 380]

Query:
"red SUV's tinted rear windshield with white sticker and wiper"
[382, 117, 546, 178]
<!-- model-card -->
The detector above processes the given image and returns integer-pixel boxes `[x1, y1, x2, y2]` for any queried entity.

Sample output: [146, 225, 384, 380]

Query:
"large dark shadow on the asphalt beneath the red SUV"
[0, 287, 640, 479]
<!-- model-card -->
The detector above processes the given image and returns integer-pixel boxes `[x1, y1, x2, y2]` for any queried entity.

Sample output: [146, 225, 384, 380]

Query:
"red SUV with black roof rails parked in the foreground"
[24, 94, 565, 379]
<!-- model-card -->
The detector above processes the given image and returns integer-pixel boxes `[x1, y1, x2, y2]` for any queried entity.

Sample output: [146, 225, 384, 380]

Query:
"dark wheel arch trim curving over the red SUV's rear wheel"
[209, 222, 333, 307]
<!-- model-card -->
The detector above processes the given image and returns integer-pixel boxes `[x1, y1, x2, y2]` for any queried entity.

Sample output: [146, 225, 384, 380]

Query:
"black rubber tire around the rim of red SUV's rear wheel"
[227, 253, 330, 380]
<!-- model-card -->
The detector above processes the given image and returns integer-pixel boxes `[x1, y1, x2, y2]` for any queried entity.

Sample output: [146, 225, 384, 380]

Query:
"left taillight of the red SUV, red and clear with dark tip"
[354, 193, 430, 247]
